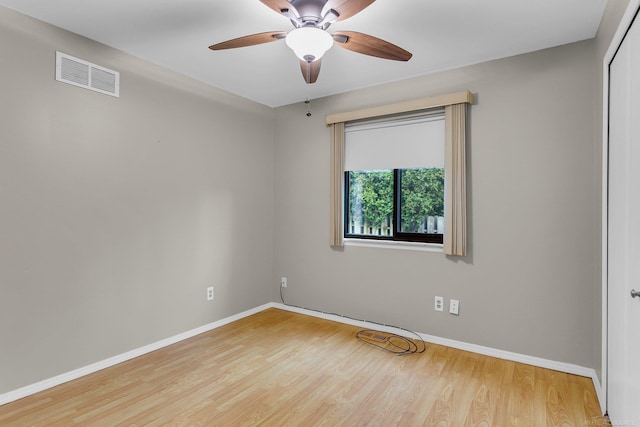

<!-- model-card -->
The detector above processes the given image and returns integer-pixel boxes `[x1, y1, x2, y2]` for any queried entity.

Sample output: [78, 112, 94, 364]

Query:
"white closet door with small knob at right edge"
[607, 11, 640, 426]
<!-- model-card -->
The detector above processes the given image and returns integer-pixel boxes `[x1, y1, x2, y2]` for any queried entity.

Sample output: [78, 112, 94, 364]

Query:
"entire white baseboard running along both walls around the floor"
[0, 302, 605, 414]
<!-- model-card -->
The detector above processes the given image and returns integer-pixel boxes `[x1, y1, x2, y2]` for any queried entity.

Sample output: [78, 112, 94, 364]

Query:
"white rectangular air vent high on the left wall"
[56, 52, 120, 97]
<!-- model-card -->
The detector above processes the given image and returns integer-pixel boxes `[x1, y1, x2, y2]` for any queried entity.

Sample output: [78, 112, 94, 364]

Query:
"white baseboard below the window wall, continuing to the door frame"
[273, 303, 605, 411]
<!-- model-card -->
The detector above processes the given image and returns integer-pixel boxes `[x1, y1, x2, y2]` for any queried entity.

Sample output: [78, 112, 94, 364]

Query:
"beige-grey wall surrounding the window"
[273, 40, 599, 367]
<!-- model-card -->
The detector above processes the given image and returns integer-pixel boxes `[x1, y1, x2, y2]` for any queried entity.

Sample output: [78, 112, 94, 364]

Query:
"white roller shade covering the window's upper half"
[344, 111, 445, 171]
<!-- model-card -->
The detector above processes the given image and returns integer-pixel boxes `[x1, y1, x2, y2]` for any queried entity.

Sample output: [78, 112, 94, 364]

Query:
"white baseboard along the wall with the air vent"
[0, 304, 272, 405]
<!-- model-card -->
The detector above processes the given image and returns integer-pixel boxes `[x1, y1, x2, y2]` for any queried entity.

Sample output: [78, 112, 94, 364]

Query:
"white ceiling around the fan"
[0, 0, 607, 107]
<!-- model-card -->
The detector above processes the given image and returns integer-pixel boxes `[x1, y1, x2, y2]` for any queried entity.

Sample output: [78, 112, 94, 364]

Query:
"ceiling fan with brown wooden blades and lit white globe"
[209, 0, 412, 83]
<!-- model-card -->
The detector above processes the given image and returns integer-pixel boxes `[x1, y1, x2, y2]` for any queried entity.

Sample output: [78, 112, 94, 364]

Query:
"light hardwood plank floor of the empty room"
[0, 309, 604, 427]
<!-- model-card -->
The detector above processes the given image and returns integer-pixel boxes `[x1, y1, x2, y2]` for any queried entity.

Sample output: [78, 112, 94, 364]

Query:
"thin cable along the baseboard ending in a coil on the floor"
[280, 286, 427, 356]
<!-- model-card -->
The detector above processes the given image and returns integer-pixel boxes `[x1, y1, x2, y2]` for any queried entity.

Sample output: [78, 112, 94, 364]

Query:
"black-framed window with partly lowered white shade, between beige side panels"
[343, 109, 445, 244]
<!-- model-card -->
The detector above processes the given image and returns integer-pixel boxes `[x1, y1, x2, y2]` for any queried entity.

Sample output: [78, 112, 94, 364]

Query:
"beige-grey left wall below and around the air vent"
[0, 8, 273, 394]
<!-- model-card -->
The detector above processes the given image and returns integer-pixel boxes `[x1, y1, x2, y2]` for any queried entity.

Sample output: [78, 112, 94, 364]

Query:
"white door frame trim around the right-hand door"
[596, 0, 640, 413]
